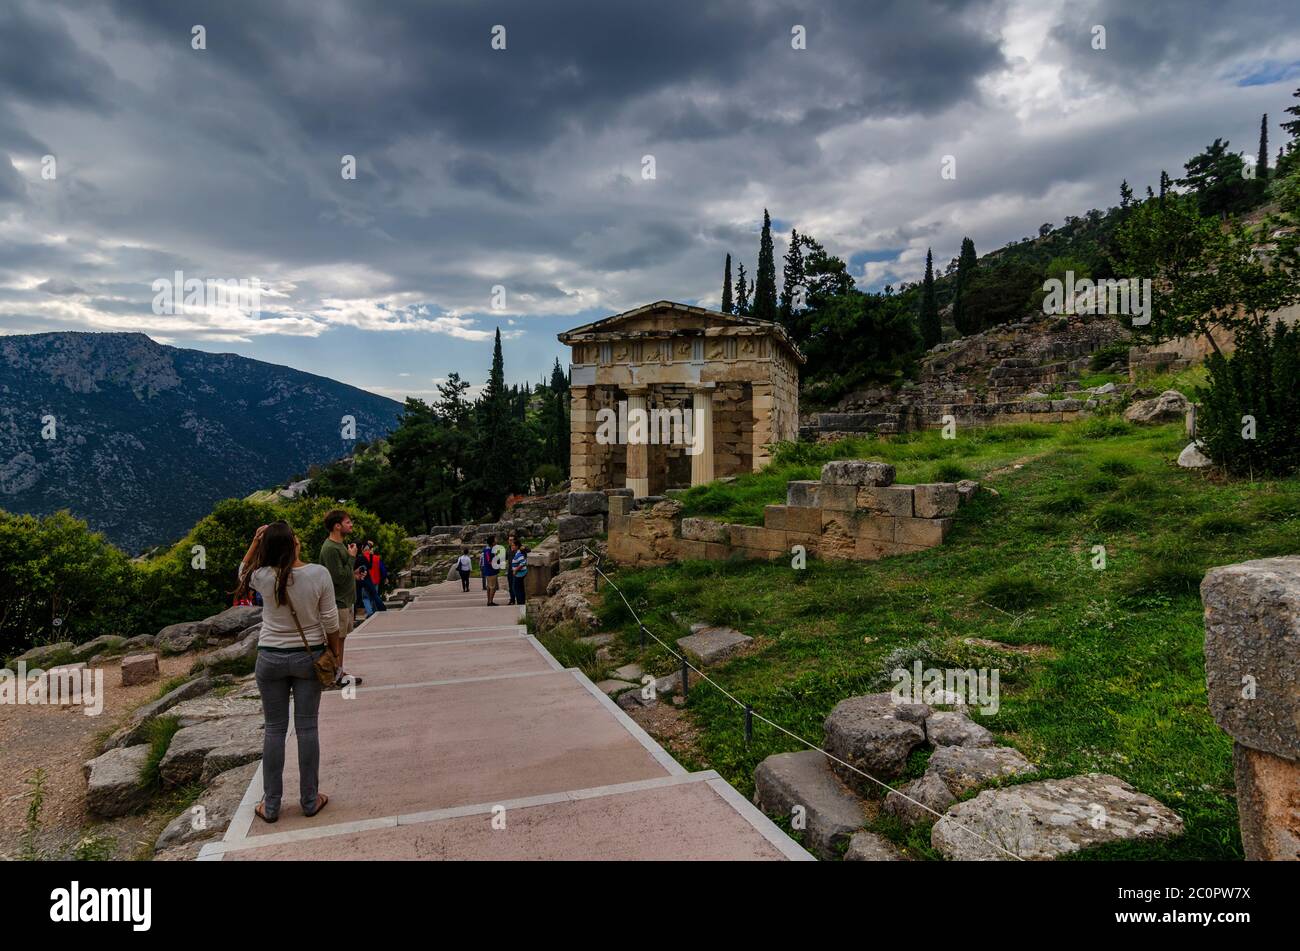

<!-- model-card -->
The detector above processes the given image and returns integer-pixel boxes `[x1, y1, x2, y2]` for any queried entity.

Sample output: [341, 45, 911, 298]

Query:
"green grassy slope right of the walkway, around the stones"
[598, 418, 1300, 860]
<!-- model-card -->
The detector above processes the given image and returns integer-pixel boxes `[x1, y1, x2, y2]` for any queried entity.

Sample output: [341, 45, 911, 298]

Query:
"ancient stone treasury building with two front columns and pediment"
[559, 300, 805, 498]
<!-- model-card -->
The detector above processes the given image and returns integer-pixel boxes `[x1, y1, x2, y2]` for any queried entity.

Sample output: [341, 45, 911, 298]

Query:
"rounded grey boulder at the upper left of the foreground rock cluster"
[824, 694, 930, 795]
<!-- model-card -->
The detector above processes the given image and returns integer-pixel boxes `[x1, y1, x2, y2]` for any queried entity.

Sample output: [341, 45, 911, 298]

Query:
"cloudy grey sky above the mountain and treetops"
[0, 0, 1300, 399]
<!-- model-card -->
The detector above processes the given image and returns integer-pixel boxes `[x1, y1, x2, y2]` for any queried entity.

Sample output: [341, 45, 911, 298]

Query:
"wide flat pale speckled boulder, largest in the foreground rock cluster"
[930, 773, 1183, 861]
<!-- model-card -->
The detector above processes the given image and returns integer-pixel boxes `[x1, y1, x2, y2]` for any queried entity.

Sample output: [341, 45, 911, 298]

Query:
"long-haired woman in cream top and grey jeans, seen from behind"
[235, 522, 342, 822]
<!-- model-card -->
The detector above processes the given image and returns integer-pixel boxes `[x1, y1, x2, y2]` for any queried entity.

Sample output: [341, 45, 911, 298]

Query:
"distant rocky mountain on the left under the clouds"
[0, 333, 402, 555]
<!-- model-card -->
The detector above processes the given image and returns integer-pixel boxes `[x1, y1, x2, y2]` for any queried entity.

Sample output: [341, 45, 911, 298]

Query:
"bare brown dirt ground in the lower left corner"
[0, 653, 195, 859]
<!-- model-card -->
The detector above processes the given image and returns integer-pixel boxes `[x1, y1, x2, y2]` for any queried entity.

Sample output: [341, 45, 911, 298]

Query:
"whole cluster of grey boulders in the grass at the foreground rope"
[754, 694, 1183, 861]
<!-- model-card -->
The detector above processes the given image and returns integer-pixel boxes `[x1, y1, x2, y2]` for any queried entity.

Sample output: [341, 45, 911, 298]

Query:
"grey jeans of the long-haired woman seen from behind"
[256, 651, 321, 818]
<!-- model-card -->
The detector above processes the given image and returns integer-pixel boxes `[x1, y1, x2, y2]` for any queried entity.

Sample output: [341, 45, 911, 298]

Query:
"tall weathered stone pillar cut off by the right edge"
[1201, 555, 1300, 861]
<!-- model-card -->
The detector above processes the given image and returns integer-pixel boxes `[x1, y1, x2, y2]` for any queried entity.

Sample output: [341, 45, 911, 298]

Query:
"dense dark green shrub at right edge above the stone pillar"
[1196, 321, 1300, 476]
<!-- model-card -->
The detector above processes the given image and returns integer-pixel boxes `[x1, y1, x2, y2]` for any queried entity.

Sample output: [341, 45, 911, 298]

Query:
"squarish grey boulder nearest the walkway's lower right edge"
[754, 750, 867, 859]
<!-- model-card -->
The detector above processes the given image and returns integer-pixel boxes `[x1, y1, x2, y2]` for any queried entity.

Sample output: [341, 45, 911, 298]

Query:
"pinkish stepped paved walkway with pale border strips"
[199, 581, 811, 861]
